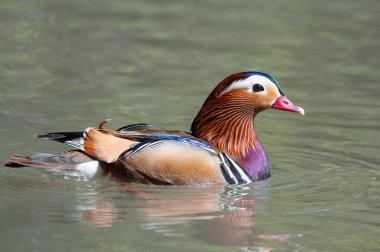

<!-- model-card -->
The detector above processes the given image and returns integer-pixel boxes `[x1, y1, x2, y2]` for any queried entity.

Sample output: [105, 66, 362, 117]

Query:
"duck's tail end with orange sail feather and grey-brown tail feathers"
[4, 119, 132, 171]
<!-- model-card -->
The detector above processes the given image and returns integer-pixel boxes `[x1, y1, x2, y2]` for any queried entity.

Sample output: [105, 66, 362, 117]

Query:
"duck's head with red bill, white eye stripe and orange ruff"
[191, 72, 305, 155]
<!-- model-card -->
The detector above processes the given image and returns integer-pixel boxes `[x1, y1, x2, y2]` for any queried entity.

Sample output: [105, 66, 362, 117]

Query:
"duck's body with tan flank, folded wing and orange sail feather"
[84, 128, 250, 185]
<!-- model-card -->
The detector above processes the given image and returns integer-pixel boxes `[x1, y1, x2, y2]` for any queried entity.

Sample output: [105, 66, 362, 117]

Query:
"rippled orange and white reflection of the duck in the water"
[81, 181, 299, 251]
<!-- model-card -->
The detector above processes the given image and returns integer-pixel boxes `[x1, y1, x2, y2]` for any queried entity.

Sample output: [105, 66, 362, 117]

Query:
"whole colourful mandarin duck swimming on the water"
[5, 72, 304, 185]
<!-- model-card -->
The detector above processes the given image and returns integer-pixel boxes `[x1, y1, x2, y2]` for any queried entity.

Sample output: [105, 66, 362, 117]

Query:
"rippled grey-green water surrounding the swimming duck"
[0, 0, 380, 252]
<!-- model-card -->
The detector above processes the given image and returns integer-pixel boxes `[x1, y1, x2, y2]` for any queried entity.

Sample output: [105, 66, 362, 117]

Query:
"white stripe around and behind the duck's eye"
[222, 75, 275, 95]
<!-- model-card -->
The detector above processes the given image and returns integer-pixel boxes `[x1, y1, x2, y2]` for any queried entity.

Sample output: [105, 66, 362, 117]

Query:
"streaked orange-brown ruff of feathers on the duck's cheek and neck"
[193, 89, 256, 157]
